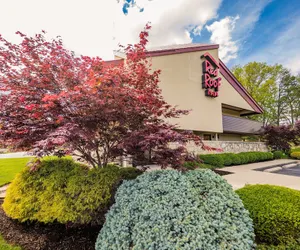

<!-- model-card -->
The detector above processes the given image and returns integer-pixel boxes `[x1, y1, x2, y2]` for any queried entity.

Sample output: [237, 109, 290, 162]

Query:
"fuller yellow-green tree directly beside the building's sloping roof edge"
[232, 62, 283, 125]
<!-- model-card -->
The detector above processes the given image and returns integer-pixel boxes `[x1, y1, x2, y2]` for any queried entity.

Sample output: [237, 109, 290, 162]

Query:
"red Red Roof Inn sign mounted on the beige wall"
[201, 52, 222, 97]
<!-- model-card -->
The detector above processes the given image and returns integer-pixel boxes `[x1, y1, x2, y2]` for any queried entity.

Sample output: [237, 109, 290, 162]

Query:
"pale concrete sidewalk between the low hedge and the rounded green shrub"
[219, 159, 300, 190]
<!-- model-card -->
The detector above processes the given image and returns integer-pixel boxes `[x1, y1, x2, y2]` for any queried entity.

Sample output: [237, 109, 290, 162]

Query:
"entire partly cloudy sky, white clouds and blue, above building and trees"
[0, 0, 300, 74]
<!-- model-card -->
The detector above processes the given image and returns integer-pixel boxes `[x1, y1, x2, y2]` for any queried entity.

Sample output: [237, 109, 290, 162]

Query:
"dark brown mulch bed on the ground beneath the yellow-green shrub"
[0, 200, 101, 250]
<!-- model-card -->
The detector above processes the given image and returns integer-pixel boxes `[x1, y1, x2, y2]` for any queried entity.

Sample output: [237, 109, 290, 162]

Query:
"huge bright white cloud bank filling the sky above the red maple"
[0, 0, 221, 59]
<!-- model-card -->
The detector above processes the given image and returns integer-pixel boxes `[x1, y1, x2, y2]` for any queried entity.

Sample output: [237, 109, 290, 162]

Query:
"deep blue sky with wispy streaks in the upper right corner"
[193, 0, 300, 72]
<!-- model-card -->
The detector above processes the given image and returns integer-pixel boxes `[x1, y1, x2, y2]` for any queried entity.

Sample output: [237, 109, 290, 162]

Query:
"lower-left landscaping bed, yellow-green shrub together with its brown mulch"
[0, 157, 141, 250]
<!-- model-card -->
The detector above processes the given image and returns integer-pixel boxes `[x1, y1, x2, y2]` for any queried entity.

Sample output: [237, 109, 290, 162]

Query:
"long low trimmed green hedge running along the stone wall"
[199, 152, 274, 168]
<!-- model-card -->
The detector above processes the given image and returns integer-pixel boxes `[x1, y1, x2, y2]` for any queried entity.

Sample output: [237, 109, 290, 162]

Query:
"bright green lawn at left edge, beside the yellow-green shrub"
[0, 157, 31, 187]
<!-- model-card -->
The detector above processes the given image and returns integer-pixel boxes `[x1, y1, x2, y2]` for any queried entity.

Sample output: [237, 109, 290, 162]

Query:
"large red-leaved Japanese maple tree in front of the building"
[0, 25, 203, 168]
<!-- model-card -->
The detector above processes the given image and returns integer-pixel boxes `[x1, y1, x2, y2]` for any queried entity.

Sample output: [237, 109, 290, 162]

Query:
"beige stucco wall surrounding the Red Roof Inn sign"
[152, 49, 253, 133]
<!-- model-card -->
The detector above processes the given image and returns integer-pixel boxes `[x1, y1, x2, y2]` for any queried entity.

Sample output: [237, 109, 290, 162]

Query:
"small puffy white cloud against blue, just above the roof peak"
[206, 16, 239, 62]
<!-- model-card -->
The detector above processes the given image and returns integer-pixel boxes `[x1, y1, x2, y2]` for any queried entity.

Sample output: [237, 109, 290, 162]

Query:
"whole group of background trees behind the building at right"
[233, 62, 300, 126]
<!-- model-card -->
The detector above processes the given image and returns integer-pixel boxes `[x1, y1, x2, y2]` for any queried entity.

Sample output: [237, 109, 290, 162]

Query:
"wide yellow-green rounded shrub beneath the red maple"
[3, 157, 141, 224]
